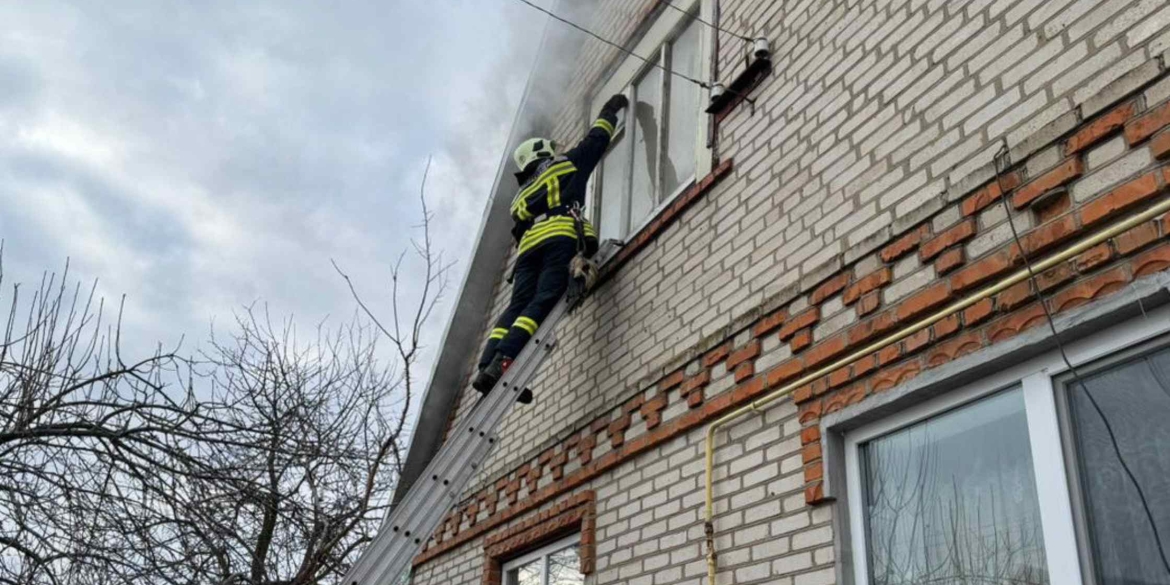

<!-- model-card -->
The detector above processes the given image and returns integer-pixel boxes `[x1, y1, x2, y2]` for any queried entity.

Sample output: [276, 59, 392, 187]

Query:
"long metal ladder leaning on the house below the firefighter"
[342, 241, 618, 585]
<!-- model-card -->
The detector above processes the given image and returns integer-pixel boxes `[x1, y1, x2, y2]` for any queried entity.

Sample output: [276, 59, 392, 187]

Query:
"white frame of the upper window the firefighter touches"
[585, 0, 714, 241]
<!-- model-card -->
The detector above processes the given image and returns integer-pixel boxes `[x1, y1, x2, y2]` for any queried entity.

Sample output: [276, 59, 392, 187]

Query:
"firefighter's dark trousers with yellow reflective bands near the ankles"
[480, 236, 577, 369]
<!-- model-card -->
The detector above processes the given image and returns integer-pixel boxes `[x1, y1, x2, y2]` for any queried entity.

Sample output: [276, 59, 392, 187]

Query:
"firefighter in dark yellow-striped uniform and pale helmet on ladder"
[472, 94, 629, 404]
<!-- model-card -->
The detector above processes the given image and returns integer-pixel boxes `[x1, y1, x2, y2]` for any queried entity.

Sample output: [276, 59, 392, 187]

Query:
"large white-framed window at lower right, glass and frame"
[844, 309, 1170, 585]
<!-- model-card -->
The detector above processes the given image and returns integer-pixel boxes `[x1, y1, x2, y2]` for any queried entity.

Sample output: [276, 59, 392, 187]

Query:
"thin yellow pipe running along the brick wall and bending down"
[703, 199, 1170, 585]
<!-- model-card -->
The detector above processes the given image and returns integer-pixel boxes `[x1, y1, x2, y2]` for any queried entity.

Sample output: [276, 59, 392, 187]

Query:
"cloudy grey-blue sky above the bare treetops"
[0, 0, 552, 393]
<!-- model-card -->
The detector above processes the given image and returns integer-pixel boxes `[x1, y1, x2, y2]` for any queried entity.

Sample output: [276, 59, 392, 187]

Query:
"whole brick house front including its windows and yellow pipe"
[390, 0, 1170, 585]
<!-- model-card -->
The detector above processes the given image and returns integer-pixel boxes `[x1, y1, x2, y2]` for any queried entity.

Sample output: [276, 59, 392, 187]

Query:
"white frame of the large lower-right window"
[842, 307, 1170, 585]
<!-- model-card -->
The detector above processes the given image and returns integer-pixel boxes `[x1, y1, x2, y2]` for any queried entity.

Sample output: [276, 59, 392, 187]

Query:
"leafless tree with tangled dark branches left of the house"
[0, 163, 448, 585]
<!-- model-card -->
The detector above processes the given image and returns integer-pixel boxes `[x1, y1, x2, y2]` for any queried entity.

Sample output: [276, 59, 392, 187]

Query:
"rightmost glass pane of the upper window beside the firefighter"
[662, 21, 701, 197]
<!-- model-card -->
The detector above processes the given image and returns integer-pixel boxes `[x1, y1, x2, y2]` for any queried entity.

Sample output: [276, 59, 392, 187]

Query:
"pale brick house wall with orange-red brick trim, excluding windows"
[415, 0, 1170, 585]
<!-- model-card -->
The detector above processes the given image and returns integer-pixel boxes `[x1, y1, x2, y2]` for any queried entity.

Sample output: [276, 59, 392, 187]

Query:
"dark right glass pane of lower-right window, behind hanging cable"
[1068, 350, 1170, 585]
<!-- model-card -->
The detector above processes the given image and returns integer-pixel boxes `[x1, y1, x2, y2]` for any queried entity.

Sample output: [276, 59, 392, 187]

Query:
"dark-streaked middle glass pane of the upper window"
[627, 68, 662, 228]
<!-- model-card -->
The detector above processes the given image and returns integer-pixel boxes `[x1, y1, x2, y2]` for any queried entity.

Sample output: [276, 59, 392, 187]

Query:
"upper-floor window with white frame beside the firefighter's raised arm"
[591, 2, 709, 240]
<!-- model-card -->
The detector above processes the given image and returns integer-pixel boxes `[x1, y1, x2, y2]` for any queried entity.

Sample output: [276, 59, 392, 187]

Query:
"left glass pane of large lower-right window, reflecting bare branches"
[861, 388, 1048, 585]
